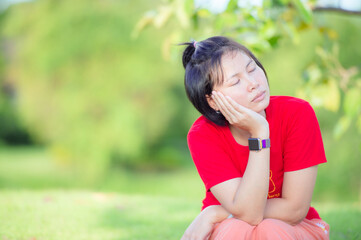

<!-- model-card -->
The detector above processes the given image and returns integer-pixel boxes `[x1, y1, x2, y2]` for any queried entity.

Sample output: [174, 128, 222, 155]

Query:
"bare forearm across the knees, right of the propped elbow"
[263, 198, 309, 225]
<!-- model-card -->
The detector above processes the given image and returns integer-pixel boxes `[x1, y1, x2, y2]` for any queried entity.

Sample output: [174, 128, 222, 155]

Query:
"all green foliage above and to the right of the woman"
[133, 0, 361, 200]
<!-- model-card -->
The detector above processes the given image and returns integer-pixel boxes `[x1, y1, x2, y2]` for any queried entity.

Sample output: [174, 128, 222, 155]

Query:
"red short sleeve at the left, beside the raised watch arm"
[188, 125, 241, 191]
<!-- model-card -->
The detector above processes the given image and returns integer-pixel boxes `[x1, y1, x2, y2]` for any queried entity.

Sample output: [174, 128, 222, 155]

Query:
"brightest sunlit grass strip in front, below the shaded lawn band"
[0, 190, 361, 240]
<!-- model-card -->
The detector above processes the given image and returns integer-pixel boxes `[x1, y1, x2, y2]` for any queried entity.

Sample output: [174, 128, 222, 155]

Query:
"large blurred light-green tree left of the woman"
[3, 0, 197, 179]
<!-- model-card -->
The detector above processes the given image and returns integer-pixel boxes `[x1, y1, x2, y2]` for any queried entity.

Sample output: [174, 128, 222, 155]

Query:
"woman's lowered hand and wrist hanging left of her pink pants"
[181, 205, 229, 240]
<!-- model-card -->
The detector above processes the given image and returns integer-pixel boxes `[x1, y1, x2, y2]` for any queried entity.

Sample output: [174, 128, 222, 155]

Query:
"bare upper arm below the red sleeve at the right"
[282, 165, 317, 217]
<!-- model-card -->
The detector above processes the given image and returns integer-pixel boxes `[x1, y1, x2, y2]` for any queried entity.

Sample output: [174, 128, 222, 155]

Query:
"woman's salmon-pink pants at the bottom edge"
[210, 218, 330, 240]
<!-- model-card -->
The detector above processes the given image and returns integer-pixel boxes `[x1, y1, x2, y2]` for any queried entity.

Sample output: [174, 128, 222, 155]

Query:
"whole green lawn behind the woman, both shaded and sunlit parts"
[0, 147, 361, 240]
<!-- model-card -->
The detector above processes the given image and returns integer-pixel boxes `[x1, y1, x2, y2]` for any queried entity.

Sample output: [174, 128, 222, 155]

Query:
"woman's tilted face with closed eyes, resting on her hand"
[213, 51, 270, 115]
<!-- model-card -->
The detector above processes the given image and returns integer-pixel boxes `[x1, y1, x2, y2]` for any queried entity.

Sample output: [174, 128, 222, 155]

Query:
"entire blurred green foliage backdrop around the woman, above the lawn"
[0, 0, 361, 200]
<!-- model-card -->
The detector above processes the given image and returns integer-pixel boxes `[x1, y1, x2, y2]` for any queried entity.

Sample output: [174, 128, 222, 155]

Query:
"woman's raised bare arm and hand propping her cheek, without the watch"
[211, 91, 270, 225]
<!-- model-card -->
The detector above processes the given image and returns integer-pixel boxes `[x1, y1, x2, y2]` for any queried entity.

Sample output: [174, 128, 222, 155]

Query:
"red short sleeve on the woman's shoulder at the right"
[283, 101, 327, 172]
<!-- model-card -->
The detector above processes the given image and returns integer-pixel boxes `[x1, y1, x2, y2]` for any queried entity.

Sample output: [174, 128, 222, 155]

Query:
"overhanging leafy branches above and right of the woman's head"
[133, 0, 361, 139]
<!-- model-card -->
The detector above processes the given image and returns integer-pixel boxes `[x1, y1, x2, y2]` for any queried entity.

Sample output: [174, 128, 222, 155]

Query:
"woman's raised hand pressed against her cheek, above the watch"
[212, 91, 269, 137]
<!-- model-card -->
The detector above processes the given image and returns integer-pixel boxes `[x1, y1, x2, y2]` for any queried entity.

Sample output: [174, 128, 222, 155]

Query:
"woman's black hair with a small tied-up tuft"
[180, 36, 268, 126]
